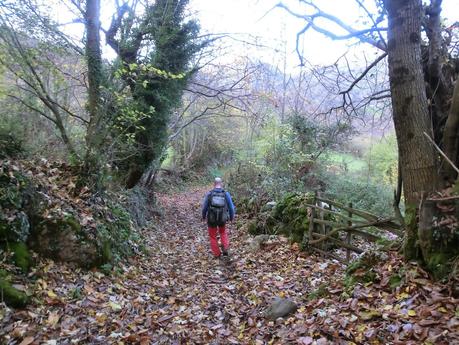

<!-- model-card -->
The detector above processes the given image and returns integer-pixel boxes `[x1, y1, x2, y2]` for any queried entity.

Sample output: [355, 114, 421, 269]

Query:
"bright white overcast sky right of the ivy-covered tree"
[190, 0, 459, 68]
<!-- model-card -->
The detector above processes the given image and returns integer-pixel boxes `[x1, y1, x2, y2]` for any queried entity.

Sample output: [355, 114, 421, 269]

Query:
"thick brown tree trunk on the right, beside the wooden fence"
[385, 0, 438, 259]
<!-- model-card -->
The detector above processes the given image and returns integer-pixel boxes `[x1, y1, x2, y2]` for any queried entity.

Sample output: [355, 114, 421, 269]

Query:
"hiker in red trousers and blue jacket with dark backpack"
[202, 177, 234, 258]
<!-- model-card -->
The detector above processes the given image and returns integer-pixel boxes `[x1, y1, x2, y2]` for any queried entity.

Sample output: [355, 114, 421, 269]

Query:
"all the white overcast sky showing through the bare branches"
[57, 0, 459, 72]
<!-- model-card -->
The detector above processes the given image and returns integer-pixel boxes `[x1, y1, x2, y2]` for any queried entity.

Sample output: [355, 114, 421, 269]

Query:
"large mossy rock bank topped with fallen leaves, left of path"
[0, 161, 144, 271]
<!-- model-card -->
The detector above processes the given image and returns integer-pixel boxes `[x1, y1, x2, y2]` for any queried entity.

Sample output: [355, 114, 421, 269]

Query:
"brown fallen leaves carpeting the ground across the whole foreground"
[0, 189, 459, 345]
